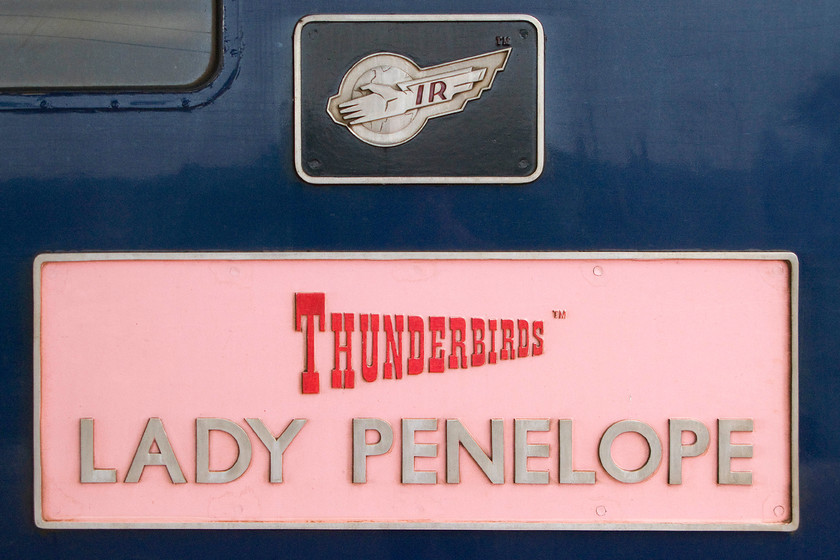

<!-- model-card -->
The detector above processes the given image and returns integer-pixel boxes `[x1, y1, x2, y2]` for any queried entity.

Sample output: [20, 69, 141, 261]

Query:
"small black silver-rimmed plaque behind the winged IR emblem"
[295, 15, 544, 183]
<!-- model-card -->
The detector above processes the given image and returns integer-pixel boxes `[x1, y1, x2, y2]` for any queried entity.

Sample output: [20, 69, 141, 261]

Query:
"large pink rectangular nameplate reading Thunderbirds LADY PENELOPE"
[34, 253, 799, 531]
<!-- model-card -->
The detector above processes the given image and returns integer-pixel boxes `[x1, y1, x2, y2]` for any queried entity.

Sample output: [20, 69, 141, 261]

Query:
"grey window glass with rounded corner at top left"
[0, 0, 216, 89]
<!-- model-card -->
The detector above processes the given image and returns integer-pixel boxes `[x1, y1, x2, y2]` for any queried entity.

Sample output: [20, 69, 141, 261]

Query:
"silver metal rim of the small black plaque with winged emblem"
[294, 14, 545, 185]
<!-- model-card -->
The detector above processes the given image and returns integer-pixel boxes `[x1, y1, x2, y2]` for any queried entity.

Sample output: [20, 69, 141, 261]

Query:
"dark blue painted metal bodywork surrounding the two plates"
[0, 0, 840, 559]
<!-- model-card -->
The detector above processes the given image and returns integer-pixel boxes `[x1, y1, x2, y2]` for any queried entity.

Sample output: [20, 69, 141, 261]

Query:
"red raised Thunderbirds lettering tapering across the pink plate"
[295, 293, 545, 393]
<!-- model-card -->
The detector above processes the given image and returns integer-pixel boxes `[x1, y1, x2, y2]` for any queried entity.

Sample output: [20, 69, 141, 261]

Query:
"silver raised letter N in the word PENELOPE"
[446, 418, 505, 484]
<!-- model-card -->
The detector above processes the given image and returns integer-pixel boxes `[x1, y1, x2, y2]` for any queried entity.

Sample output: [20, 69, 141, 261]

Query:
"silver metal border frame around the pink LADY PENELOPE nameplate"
[33, 251, 800, 532]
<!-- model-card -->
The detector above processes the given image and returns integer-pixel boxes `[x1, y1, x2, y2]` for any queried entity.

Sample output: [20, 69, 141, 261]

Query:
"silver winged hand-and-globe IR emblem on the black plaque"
[327, 49, 510, 148]
